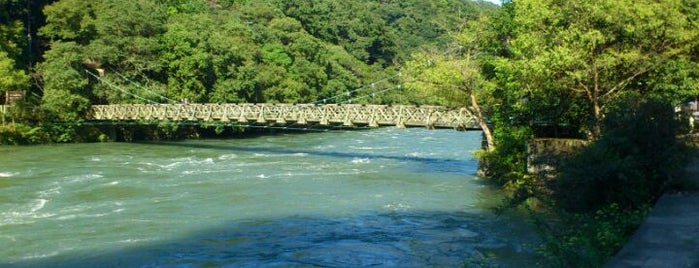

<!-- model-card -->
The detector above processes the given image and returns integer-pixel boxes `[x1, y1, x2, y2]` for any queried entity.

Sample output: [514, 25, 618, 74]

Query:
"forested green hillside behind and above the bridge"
[0, 0, 496, 121]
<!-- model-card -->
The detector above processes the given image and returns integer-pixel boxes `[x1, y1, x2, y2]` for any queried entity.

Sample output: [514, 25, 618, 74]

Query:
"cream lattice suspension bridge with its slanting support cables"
[0, 70, 480, 130]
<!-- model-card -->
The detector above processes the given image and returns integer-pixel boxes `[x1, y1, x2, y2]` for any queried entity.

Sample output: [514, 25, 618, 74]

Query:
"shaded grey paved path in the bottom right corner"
[605, 156, 699, 268]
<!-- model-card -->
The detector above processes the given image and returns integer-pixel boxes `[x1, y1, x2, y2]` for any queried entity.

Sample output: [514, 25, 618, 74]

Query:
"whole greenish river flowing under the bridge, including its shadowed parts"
[0, 128, 534, 267]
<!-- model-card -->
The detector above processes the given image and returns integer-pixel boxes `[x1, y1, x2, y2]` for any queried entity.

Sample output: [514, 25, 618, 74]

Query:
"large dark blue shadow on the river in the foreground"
[0, 211, 533, 267]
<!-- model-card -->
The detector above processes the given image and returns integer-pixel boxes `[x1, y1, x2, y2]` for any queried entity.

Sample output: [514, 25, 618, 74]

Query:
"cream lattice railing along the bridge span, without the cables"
[89, 103, 478, 129]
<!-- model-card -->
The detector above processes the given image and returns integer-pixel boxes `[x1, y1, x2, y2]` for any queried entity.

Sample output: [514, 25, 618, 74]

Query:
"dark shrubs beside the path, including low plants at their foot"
[517, 93, 687, 267]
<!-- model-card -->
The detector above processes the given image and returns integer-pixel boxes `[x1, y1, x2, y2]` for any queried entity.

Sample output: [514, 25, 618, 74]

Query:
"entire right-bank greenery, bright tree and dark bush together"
[474, 0, 699, 267]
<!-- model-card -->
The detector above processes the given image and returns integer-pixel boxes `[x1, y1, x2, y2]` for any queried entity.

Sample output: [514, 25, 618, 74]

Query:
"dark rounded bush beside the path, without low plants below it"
[549, 94, 687, 212]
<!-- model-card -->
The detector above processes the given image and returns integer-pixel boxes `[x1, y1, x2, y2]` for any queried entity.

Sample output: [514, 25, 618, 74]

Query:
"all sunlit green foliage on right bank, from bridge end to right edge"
[470, 0, 699, 196]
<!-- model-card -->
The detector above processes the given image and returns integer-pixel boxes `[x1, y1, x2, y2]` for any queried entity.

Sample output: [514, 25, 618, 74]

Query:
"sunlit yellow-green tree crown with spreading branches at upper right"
[501, 0, 699, 137]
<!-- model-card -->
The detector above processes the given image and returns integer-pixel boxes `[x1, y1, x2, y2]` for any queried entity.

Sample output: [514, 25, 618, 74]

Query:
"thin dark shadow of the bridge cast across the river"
[144, 142, 478, 175]
